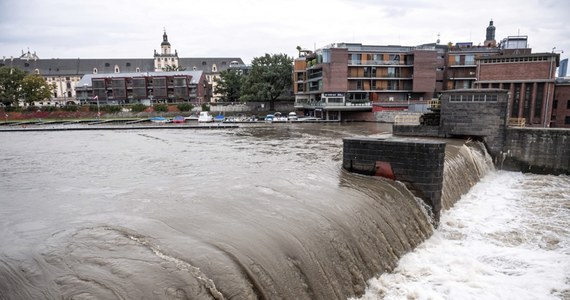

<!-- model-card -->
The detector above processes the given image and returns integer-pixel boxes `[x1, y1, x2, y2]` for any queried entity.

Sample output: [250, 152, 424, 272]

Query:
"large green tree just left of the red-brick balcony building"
[240, 54, 293, 110]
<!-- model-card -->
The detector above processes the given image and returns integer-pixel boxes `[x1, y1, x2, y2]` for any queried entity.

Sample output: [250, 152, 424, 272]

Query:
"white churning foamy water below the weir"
[350, 172, 570, 299]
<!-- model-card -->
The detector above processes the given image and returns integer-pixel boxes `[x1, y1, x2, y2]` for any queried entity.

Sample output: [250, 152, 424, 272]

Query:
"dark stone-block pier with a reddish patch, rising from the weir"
[342, 138, 445, 222]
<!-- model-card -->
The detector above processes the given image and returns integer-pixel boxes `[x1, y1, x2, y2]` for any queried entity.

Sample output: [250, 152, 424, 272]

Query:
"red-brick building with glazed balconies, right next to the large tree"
[293, 43, 444, 119]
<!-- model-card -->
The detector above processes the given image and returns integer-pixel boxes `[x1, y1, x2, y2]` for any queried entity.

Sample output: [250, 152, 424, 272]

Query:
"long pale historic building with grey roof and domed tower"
[0, 31, 245, 105]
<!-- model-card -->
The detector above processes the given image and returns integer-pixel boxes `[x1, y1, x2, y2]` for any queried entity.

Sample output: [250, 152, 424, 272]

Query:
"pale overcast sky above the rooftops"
[0, 0, 570, 67]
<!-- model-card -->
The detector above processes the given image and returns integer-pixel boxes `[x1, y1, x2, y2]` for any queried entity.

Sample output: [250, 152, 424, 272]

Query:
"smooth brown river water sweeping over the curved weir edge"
[0, 123, 567, 299]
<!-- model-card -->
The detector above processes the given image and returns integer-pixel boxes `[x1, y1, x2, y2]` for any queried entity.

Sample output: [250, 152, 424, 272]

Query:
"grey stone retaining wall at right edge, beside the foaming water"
[499, 128, 570, 175]
